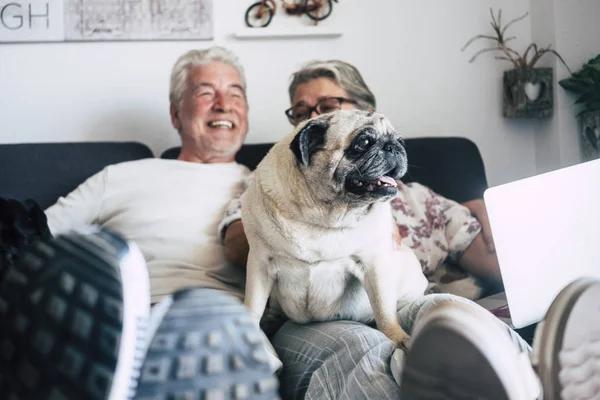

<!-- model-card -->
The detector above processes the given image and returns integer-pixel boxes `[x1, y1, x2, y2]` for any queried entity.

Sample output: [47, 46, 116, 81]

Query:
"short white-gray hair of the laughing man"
[169, 46, 246, 107]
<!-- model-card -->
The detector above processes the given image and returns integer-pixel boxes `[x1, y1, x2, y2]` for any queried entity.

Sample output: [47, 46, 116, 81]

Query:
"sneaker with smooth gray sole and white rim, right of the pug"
[401, 303, 541, 400]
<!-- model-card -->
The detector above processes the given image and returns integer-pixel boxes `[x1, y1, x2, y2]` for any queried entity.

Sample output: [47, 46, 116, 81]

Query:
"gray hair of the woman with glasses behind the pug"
[288, 60, 376, 111]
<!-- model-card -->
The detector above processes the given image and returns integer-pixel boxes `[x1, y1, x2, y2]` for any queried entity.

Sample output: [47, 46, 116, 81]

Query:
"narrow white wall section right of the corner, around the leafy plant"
[531, 0, 600, 173]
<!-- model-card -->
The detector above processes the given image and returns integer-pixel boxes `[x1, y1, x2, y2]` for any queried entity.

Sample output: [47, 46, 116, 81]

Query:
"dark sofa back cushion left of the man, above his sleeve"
[0, 142, 154, 209]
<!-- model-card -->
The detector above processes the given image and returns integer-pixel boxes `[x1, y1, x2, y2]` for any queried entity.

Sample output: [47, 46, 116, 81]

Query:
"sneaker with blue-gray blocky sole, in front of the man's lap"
[136, 288, 279, 400]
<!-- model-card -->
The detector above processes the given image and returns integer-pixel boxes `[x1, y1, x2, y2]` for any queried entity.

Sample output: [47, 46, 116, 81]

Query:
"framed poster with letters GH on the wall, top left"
[0, 0, 213, 43]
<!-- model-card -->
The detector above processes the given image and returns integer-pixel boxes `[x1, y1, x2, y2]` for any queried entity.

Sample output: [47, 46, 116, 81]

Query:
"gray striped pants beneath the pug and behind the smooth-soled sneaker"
[272, 294, 531, 400]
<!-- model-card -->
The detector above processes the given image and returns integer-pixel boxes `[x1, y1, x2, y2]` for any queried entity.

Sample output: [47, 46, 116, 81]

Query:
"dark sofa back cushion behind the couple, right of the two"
[161, 137, 488, 203]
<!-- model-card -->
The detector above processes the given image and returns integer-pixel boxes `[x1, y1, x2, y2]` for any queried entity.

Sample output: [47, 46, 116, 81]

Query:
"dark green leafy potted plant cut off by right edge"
[558, 54, 600, 158]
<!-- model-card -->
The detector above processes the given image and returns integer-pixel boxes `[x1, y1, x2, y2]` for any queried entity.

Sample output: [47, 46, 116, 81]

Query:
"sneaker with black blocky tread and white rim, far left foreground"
[0, 231, 150, 400]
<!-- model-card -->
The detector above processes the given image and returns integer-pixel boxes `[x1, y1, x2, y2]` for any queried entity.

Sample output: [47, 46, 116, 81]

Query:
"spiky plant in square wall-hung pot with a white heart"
[461, 8, 570, 118]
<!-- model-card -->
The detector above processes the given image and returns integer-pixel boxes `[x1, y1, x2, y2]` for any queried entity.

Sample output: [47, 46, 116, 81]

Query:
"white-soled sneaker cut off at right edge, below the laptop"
[532, 278, 600, 400]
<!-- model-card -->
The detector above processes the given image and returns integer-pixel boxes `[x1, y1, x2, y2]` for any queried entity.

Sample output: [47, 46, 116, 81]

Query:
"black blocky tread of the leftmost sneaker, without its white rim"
[0, 235, 126, 400]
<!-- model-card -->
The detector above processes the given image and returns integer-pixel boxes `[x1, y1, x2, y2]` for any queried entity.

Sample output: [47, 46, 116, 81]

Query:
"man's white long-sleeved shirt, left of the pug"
[46, 159, 250, 303]
